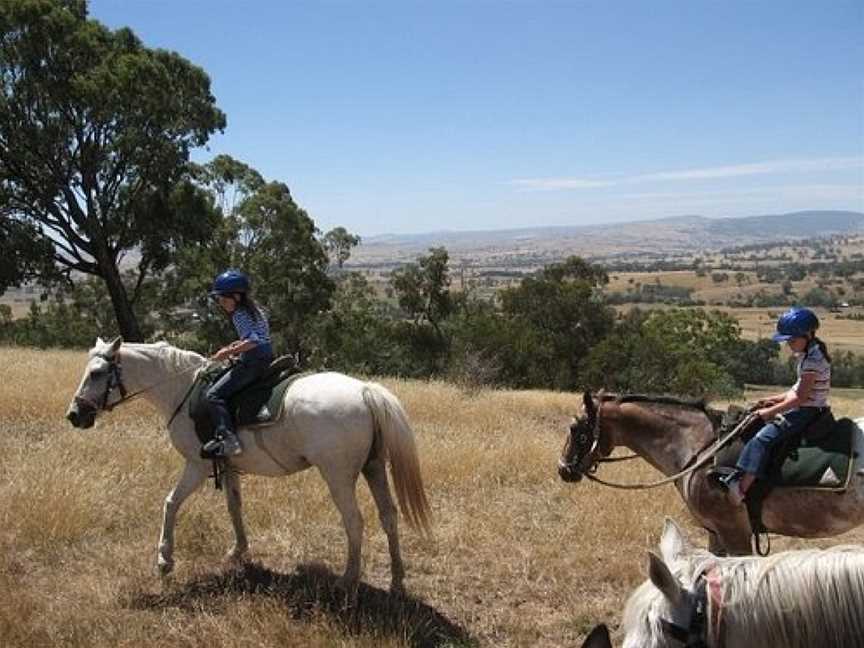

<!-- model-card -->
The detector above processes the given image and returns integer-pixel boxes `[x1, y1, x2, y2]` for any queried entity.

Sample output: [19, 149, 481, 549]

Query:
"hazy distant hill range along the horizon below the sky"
[348, 211, 864, 266]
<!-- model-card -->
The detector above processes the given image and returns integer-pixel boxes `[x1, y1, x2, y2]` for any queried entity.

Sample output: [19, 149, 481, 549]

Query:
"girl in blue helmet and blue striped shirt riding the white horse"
[202, 270, 273, 458]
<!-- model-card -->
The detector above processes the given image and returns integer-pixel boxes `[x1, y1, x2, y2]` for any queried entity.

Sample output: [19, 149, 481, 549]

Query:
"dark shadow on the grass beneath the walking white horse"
[125, 562, 477, 648]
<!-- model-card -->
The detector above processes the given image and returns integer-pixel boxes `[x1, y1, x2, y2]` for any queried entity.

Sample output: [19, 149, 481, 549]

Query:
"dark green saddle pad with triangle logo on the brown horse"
[772, 418, 857, 490]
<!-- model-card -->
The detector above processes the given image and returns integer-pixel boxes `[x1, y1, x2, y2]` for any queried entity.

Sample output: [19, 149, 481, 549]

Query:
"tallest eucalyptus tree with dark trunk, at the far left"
[0, 0, 225, 340]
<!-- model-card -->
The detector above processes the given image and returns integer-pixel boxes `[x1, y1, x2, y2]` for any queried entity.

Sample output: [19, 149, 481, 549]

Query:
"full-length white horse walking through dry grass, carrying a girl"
[67, 338, 429, 592]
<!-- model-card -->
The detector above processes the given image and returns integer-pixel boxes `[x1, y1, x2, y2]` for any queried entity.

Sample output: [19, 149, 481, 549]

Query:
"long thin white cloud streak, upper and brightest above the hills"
[511, 157, 864, 191]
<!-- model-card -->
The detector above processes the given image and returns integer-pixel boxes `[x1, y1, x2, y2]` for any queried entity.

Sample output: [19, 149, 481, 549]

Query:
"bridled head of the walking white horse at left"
[66, 337, 123, 428]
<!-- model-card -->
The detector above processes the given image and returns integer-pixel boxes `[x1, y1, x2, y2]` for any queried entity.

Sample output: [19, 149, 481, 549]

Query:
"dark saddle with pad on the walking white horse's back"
[189, 356, 302, 445]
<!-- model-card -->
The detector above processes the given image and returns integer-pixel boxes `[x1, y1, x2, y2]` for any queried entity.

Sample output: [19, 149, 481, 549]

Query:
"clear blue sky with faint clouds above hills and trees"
[90, 0, 864, 236]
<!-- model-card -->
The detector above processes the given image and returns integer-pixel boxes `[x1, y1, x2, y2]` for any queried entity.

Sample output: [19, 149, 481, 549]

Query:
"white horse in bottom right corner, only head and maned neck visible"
[616, 519, 864, 648]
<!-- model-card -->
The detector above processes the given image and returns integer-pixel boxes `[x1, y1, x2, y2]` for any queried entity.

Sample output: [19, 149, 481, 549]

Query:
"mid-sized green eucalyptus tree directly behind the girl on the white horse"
[159, 155, 334, 356]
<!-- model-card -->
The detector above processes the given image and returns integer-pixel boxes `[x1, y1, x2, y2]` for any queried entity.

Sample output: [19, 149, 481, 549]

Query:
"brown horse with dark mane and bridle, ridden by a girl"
[558, 392, 864, 554]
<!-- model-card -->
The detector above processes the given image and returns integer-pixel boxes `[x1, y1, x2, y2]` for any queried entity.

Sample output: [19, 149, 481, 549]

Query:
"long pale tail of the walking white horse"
[363, 382, 430, 535]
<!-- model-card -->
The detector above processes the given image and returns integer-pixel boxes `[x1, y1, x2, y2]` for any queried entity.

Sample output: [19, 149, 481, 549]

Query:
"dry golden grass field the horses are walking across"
[0, 349, 864, 648]
